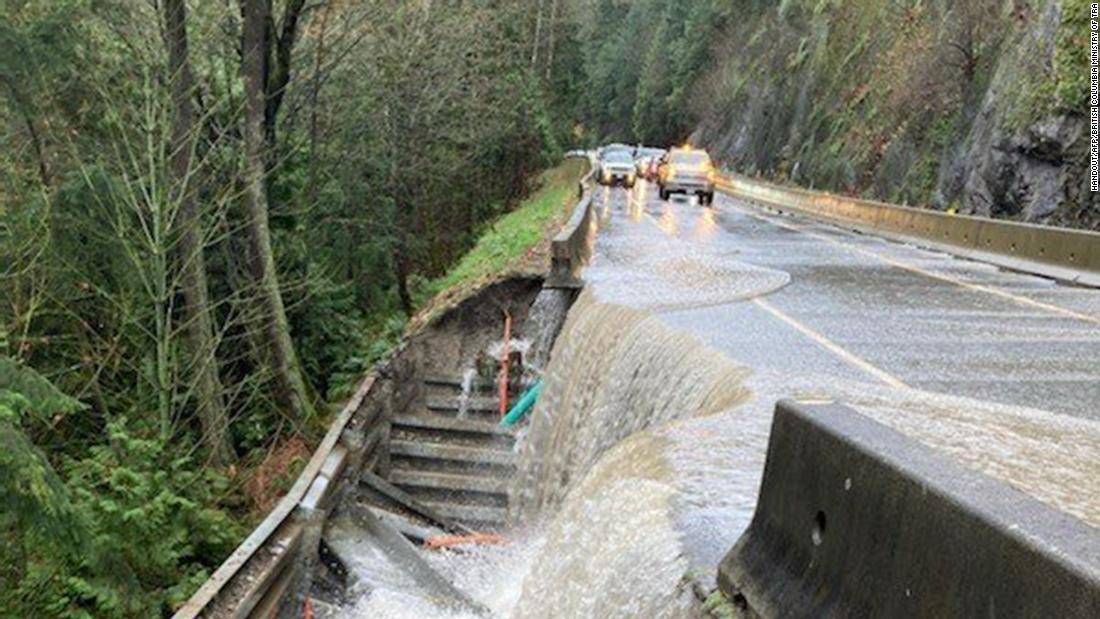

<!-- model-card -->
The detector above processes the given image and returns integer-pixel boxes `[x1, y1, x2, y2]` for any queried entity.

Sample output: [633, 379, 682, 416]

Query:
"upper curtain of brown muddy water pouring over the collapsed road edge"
[512, 292, 746, 521]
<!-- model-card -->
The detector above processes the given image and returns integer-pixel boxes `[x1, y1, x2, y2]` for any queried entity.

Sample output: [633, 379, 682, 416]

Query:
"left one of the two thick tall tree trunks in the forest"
[164, 0, 233, 464]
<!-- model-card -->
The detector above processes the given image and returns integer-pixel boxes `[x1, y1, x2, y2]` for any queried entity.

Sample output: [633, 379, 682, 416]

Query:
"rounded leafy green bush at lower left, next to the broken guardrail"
[65, 420, 243, 616]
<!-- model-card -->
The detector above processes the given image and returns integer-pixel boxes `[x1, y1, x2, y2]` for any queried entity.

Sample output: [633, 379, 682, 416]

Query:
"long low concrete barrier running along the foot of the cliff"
[718, 174, 1100, 286]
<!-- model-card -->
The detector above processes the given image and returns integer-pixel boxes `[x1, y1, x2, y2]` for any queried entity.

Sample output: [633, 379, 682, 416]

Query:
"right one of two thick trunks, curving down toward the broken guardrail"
[241, 0, 312, 420]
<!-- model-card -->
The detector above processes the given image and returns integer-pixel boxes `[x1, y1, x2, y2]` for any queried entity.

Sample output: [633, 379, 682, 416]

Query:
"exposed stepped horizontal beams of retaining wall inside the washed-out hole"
[363, 376, 515, 532]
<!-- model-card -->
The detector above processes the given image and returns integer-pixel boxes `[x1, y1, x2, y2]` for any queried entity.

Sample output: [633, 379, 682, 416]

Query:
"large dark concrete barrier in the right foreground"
[718, 401, 1100, 619]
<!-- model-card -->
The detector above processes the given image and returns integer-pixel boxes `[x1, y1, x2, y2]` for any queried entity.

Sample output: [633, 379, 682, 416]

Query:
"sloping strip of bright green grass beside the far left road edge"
[415, 159, 587, 299]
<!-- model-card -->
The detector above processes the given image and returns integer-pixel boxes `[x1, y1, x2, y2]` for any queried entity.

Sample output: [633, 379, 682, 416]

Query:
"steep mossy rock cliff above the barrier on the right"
[692, 0, 1100, 229]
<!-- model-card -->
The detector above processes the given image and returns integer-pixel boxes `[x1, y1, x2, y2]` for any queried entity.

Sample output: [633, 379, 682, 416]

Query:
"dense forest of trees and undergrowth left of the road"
[0, 0, 633, 617]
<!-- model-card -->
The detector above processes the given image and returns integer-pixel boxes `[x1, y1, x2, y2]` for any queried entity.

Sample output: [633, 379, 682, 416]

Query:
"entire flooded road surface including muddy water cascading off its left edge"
[345, 185, 1100, 618]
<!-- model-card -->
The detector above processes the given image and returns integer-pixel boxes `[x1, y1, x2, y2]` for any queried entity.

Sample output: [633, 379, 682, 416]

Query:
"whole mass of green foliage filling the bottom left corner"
[0, 357, 241, 617]
